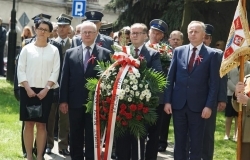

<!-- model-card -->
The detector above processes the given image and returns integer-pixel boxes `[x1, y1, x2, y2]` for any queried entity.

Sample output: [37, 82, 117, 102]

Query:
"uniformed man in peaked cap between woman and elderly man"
[46, 14, 73, 155]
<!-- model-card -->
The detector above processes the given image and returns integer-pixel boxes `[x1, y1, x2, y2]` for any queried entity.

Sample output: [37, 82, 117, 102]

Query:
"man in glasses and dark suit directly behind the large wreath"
[116, 23, 162, 160]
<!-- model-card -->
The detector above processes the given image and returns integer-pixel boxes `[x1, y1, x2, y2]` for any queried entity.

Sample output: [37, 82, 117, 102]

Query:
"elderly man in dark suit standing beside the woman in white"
[59, 21, 110, 160]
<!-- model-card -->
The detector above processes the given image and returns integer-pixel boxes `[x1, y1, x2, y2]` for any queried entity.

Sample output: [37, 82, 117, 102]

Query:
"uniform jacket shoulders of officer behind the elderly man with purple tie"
[71, 33, 114, 53]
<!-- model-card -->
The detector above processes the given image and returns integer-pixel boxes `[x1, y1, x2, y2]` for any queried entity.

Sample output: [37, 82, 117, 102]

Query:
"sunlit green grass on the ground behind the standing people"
[0, 79, 236, 160]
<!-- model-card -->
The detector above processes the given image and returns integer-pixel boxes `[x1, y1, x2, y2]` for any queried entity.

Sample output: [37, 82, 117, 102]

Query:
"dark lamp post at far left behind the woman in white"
[6, 0, 17, 83]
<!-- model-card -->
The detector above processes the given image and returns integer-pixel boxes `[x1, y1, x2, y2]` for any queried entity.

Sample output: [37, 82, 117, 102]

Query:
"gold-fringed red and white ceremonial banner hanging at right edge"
[220, 0, 250, 77]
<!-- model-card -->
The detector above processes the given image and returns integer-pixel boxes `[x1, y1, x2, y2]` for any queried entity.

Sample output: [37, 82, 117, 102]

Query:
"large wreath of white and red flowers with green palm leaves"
[86, 45, 167, 138]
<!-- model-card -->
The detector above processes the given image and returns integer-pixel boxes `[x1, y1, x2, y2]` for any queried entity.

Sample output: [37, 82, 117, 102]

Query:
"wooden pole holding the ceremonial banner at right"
[237, 0, 246, 160]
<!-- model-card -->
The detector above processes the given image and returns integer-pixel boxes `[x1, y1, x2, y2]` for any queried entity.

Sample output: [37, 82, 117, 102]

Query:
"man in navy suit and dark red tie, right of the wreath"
[164, 21, 219, 160]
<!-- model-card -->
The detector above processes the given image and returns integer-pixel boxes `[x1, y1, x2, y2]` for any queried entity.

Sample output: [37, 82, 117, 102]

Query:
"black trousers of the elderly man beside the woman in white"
[69, 107, 94, 160]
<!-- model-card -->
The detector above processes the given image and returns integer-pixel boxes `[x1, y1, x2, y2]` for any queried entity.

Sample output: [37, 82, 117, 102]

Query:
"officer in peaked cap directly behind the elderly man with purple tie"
[72, 11, 114, 52]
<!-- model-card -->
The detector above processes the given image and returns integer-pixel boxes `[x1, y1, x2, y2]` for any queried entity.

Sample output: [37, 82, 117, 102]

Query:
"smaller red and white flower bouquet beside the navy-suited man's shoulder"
[149, 42, 173, 69]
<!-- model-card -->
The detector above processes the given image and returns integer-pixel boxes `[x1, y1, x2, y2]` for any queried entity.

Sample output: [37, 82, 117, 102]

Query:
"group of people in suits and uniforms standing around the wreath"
[11, 7, 246, 160]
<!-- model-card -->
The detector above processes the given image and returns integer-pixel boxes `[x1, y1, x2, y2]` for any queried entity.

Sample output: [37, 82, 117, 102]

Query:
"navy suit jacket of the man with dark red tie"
[165, 45, 219, 112]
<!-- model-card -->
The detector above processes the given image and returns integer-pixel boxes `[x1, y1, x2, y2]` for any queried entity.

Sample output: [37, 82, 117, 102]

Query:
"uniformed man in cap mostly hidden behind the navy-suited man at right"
[202, 24, 227, 160]
